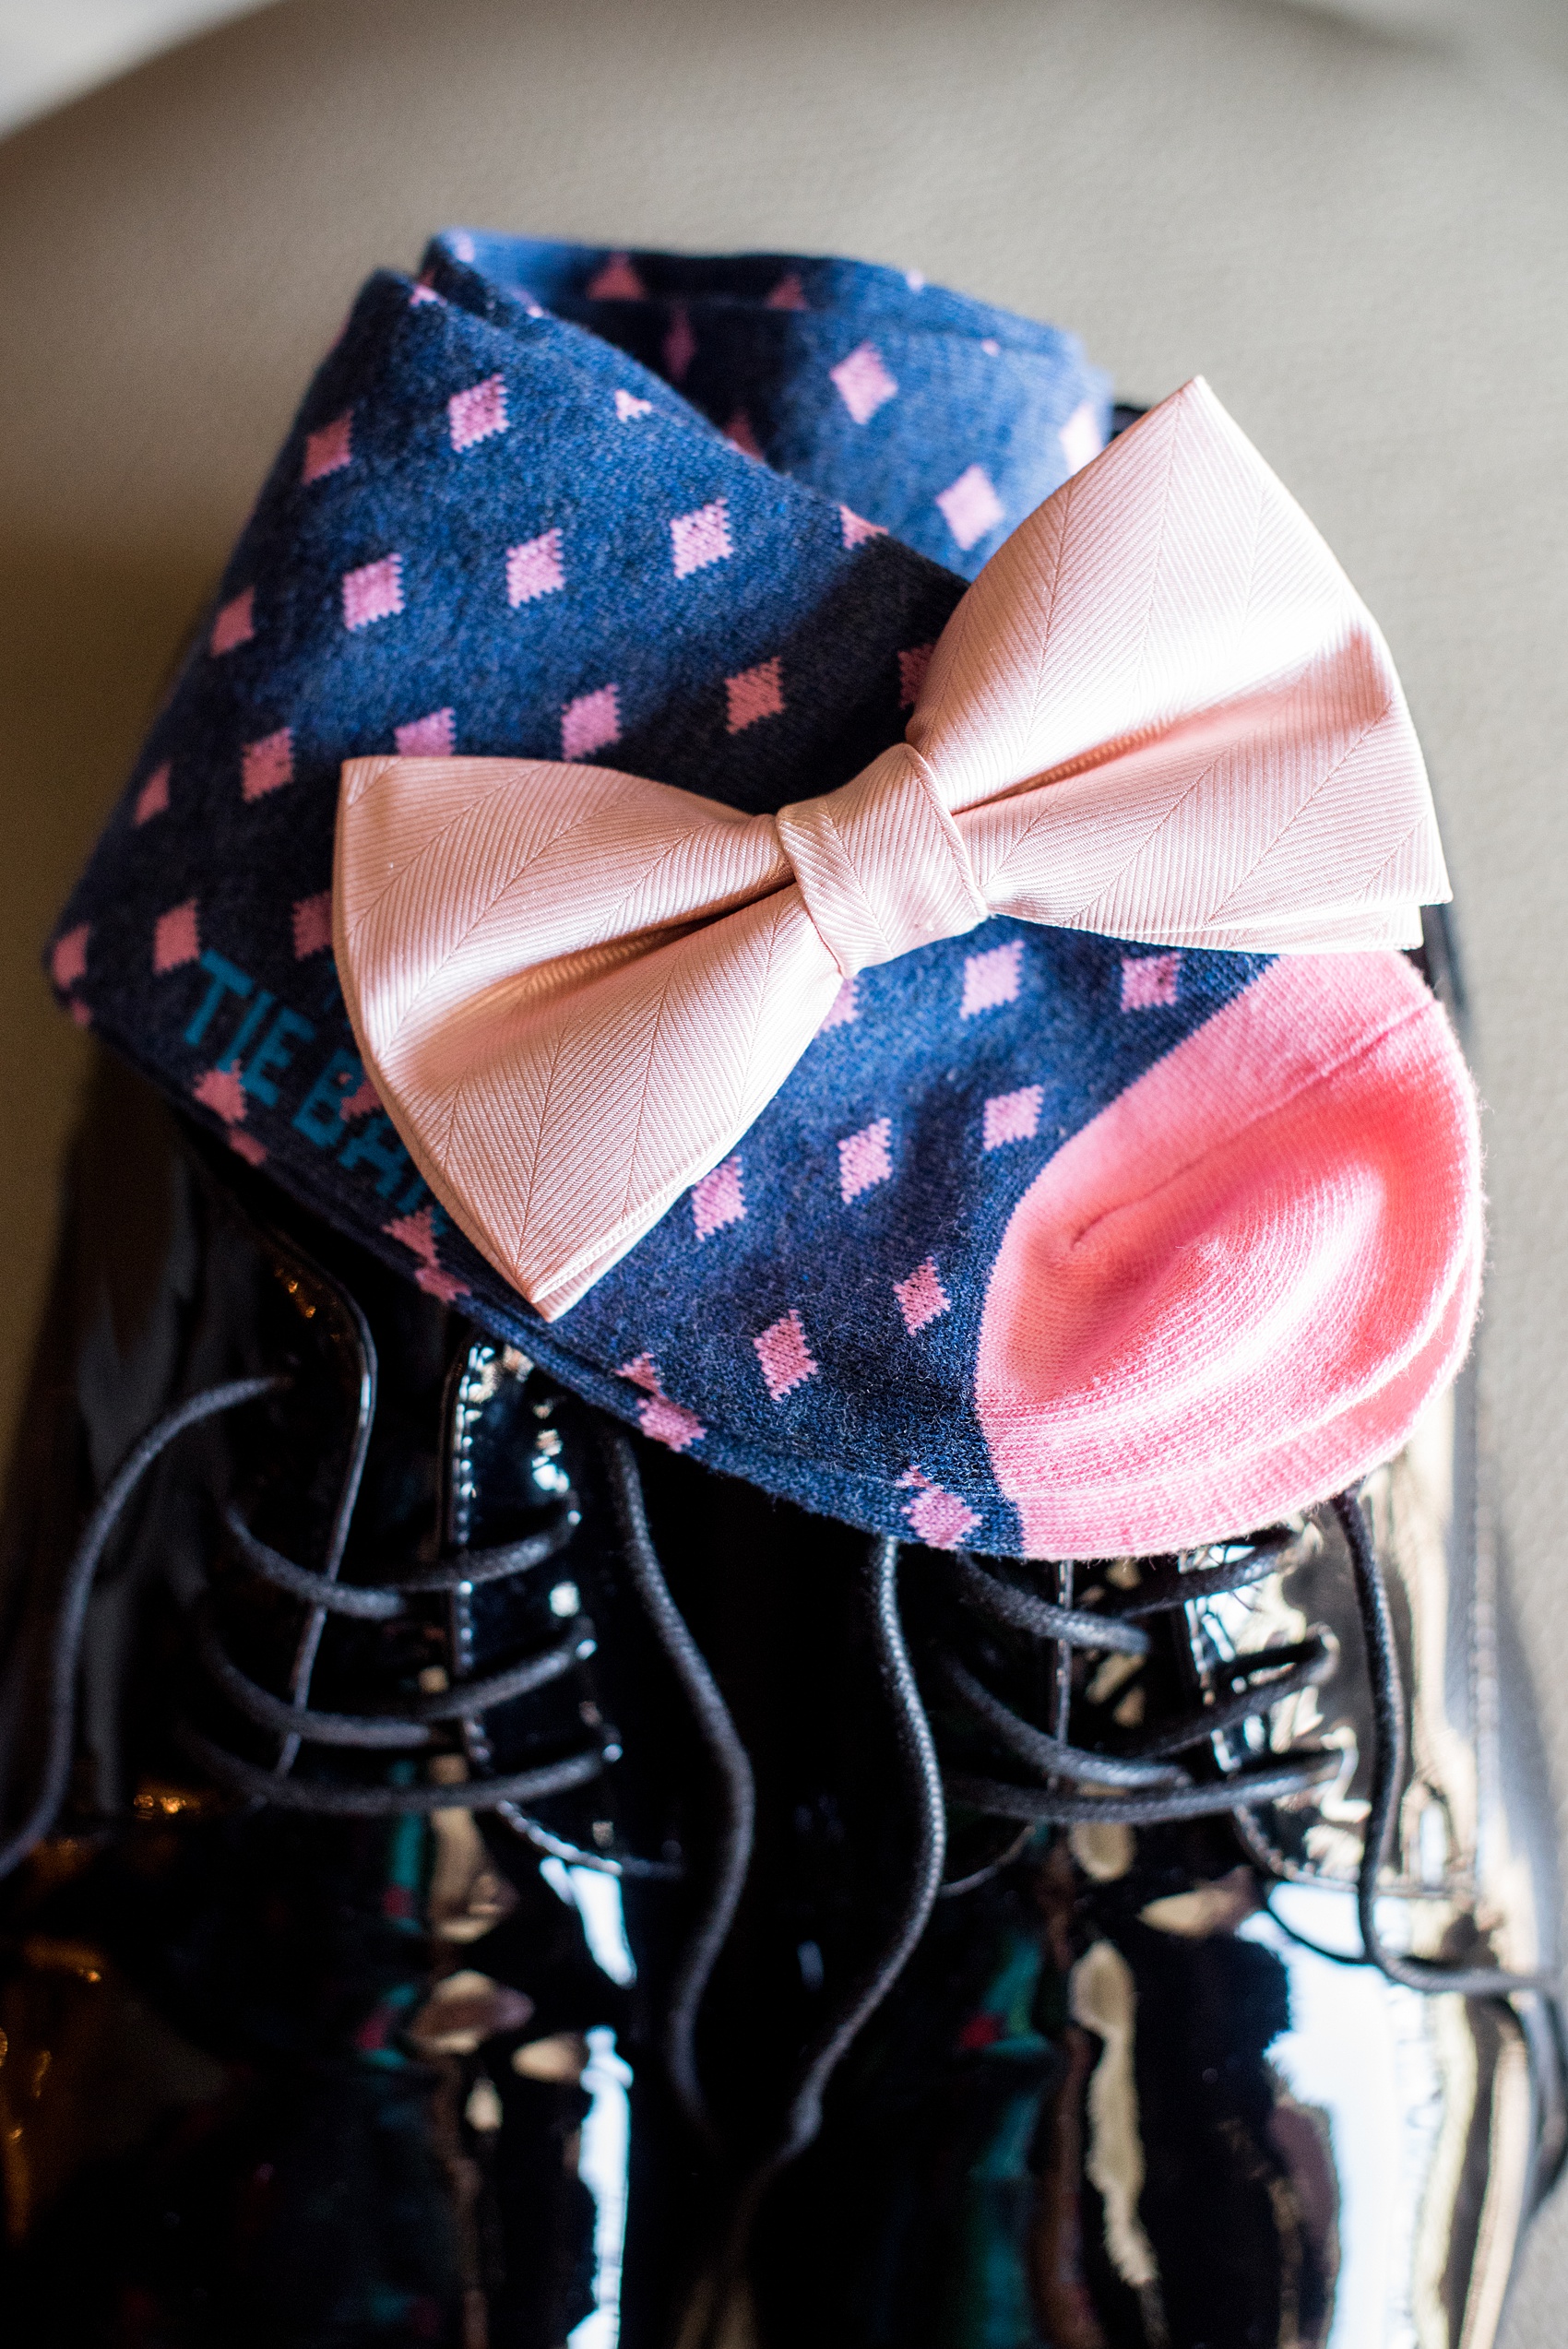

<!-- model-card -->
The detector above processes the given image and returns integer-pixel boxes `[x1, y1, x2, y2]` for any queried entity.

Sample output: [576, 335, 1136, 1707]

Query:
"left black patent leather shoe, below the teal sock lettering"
[0, 1066, 747, 2349]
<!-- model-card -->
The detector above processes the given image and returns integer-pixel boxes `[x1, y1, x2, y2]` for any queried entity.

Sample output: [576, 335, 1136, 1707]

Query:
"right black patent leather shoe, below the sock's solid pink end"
[738, 1386, 1565, 2349]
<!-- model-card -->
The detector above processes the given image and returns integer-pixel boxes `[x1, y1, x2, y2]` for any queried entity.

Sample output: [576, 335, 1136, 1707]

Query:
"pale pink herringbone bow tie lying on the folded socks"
[334, 381, 1448, 1320]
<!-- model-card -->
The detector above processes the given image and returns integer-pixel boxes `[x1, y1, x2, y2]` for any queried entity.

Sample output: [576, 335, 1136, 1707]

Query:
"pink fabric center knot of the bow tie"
[774, 742, 990, 979]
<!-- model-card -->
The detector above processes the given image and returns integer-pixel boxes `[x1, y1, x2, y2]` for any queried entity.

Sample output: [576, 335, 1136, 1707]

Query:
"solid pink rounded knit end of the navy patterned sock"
[976, 954, 1481, 1558]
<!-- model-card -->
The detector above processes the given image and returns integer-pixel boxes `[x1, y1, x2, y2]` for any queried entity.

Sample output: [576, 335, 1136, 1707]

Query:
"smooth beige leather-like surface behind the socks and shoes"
[0, 0, 1568, 2349]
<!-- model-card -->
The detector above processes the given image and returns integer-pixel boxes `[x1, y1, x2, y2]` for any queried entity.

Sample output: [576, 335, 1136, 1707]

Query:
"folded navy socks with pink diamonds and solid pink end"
[52, 232, 1479, 1553]
